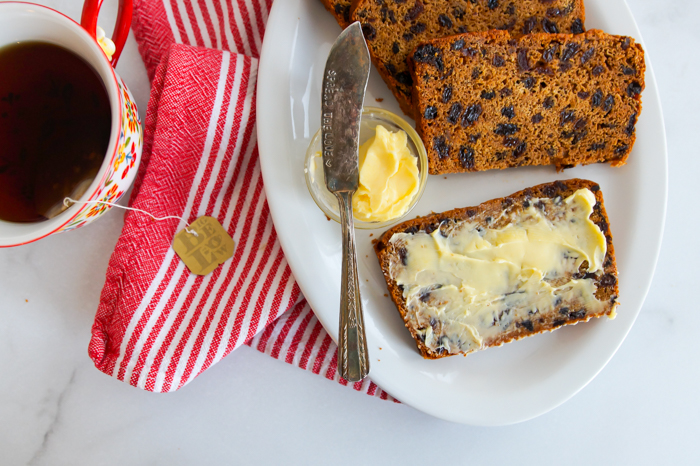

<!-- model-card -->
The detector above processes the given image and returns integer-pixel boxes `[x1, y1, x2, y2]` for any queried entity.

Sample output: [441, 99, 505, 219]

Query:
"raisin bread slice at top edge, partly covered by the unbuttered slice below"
[351, 0, 585, 116]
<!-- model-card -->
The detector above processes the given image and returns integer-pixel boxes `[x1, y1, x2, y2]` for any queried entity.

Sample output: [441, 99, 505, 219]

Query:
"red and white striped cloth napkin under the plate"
[89, 0, 393, 400]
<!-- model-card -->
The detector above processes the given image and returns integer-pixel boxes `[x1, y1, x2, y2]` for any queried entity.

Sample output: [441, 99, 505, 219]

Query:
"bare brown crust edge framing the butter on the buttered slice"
[373, 178, 619, 359]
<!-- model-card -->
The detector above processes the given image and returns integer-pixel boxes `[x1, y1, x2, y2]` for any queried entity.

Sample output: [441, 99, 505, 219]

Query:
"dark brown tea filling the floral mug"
[0, 42, 112, 222]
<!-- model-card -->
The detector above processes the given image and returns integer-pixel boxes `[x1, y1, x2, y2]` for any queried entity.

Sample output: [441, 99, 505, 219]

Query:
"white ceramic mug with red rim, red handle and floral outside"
[0, 0, 143, 247]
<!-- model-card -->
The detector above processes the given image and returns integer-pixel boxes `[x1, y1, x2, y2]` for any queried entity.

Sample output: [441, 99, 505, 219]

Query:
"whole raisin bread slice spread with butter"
[374, 179, 618, 359]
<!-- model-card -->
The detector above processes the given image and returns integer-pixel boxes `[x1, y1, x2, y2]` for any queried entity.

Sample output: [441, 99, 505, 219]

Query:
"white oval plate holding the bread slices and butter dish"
[257, 0, 667, 425]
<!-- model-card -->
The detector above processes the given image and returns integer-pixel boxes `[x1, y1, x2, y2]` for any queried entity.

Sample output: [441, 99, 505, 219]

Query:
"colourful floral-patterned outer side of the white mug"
[63, 76, 143, 233]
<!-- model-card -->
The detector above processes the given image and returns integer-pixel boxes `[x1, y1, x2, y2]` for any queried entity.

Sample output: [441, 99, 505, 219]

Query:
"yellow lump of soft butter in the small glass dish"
[352, 125, 420, 222]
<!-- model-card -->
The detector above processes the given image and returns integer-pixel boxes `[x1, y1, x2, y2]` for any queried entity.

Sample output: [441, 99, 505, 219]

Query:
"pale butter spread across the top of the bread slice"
[390, 189, 607, 353]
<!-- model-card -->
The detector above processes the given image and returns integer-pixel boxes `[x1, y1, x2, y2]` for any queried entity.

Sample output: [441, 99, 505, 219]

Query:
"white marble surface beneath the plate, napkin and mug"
[0, 0, 700, 465]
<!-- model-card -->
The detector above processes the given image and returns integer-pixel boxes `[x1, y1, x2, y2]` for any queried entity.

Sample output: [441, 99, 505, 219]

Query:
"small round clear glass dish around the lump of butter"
[304, 107, 428, 230]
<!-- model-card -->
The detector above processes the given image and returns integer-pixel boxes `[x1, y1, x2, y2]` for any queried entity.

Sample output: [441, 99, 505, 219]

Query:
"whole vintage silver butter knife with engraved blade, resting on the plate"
[321, 22, 370, 382]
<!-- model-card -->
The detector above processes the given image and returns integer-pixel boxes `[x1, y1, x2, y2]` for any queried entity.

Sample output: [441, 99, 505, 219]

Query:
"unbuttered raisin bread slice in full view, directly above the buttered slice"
[411, 30, 645, 174]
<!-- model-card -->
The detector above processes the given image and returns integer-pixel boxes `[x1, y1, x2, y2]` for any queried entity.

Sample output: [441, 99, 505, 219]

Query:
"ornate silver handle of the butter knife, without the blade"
[335, 191, 369, 382]
